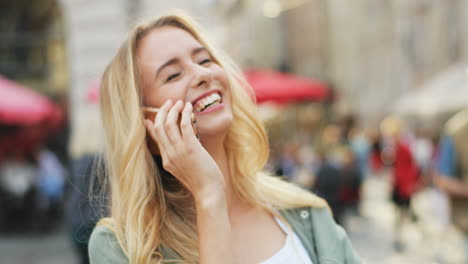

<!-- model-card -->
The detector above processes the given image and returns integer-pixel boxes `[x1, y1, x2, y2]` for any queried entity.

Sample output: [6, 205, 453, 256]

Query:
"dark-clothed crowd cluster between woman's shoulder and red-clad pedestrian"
[269, 117, 372, 227]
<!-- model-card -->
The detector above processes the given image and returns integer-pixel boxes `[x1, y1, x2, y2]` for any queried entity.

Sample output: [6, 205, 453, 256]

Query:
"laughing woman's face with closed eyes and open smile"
[137, 26, 232, 139]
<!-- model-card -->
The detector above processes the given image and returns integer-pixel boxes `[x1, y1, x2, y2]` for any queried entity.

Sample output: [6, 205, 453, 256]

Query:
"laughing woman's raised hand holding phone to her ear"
[145, 100, 225, 204]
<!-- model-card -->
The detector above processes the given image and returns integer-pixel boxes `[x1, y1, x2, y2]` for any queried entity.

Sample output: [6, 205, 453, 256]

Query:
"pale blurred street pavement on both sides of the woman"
[0, 170, 463, 264]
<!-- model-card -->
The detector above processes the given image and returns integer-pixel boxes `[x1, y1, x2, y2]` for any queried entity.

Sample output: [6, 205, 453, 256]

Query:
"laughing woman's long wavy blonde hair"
[99, 11, 326, 263]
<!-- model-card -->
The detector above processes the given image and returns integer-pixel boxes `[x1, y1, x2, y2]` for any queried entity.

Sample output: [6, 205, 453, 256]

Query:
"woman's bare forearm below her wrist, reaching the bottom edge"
[196, 193, 235, 264]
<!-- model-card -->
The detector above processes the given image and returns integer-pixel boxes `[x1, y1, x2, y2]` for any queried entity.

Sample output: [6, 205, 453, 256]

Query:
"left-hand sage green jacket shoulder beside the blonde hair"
[88, 225, 128, 264]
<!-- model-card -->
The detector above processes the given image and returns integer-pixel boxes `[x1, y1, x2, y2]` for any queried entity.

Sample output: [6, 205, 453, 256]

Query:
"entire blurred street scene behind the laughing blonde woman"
[0, 0, 468, 264]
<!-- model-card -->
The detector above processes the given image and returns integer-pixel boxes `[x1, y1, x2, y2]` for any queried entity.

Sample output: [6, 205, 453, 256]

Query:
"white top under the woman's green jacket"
[260, 217, 313, 264]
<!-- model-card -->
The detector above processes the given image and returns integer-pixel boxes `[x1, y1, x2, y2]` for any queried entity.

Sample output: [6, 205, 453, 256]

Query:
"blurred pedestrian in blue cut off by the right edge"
[434, 109, 468, 263]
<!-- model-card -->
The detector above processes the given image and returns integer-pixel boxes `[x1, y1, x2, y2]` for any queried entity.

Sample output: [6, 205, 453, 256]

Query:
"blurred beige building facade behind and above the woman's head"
[59, 0, 468, 157]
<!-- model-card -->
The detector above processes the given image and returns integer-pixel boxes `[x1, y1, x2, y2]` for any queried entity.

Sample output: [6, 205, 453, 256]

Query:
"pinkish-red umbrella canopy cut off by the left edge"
[0, 75, 57, 125]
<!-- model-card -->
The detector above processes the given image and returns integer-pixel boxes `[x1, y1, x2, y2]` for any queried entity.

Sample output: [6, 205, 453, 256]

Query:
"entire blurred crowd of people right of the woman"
[270, 110, 468, 262]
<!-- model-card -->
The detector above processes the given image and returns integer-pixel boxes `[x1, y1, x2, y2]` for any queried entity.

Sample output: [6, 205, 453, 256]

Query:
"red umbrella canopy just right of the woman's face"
[244, 70, 330, 103]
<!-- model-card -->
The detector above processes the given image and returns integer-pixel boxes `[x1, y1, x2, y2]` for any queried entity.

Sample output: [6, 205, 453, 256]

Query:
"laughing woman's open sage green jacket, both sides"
[89, 208, 361, 264]
